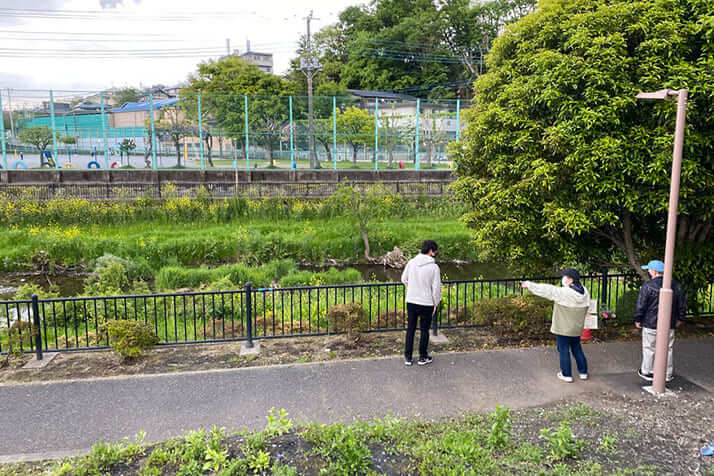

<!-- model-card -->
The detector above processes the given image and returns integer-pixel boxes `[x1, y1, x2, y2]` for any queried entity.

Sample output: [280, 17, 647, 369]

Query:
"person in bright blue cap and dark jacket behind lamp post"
[634, 260, 687, 382]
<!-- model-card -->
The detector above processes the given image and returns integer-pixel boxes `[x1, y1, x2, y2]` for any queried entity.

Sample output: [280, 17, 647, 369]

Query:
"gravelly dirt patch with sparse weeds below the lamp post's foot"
[513, 392, 714, 475]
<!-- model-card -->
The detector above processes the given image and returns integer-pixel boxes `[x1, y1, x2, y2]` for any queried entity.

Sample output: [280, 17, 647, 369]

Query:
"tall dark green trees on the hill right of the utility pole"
[289, 0, 535, 97]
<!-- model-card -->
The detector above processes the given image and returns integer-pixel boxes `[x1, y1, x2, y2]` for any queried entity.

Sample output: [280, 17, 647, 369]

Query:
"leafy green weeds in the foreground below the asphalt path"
[33, 407, 676, 476]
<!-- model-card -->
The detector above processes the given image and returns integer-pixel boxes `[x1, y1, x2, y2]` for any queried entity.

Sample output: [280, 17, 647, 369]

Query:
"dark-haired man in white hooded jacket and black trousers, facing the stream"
[402, 240, 441, 366]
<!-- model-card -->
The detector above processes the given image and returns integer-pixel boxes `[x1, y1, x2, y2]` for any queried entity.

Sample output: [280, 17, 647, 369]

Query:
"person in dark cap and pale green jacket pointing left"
[521, 268, 590, 382]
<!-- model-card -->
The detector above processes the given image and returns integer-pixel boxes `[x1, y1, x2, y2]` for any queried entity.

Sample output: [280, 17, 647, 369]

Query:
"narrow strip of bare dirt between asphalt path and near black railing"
[0, 319, 714, 382]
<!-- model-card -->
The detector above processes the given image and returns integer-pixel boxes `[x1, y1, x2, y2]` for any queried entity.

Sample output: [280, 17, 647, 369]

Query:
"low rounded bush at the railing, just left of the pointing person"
[473, 295, 552, 337]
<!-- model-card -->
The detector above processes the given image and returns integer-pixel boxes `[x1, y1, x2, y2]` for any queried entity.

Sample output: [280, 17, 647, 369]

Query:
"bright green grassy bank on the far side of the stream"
[0, 217, 478, 272]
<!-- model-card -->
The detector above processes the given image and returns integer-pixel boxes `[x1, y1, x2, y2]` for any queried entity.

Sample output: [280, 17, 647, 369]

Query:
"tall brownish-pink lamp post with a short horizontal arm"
[637, 89, 689, 394]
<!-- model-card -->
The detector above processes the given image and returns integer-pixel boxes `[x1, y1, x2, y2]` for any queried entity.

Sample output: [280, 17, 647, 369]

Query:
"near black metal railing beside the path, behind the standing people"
[0, 274, 714, 352]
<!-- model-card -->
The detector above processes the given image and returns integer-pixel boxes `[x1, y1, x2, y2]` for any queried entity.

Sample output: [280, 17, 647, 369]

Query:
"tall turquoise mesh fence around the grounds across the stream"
[0, 89, 471, 170]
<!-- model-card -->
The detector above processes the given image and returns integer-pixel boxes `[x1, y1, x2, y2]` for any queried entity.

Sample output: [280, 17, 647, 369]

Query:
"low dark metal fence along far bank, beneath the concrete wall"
[0, 180, 451, 200]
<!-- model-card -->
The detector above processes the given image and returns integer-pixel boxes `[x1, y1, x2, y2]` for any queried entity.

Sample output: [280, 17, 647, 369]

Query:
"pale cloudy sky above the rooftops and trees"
[0, 0, 362, 96]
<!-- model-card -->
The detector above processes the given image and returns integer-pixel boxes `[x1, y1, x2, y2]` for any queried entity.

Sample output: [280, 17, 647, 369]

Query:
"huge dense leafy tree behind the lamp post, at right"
[450, 0, 714, 291]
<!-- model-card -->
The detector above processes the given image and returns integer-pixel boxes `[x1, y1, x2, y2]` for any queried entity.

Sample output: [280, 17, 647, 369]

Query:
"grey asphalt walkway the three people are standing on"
[0, 339, 714, 461]
